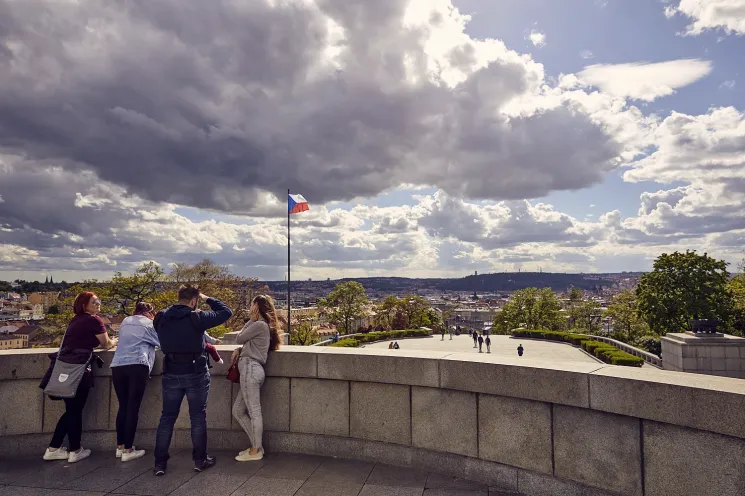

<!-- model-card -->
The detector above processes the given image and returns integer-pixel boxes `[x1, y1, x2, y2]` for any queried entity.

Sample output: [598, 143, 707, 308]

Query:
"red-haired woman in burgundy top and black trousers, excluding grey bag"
[44, 291, 116, 463]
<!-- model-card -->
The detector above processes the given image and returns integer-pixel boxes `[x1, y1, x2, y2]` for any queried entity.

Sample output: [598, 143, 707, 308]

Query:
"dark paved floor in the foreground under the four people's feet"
[0, 450, 509, 496]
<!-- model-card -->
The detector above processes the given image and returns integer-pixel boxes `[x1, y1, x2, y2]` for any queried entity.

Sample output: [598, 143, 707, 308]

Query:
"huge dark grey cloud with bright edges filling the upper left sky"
[0, 0, 620, 213]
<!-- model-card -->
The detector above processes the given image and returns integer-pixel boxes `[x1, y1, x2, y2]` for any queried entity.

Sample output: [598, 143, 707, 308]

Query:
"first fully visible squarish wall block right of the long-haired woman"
[290, 378, 349, 436]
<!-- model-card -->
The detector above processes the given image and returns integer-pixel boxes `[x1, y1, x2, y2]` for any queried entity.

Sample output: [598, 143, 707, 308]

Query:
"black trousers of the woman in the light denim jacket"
[111, 365, 150, 449]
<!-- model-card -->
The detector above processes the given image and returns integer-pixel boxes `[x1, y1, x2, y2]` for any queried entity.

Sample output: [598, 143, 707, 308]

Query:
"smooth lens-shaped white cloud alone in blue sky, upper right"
[578, 59, 712, 102]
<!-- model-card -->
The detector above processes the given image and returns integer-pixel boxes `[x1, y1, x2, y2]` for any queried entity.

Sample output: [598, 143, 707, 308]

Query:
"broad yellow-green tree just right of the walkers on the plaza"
[492, 288, 563, 334]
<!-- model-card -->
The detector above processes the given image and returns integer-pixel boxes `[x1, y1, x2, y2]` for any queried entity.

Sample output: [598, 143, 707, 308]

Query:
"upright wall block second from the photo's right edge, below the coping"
[554, 405, 642, 496]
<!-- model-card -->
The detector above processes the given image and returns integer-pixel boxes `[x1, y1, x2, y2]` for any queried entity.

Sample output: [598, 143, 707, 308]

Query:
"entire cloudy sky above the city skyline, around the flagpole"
[0, 0, 745, 280]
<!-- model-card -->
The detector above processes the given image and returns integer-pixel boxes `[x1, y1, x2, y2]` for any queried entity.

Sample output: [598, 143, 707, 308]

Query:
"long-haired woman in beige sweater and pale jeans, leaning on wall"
[233, 295, 279, 462]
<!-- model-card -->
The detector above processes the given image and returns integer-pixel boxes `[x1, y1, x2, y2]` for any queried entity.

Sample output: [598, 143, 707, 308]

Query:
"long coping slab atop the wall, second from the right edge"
[440, 354, 596, 408]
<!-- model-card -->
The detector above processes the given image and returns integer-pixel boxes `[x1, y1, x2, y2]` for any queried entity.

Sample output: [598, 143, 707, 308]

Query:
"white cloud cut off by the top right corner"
[665, 0, 745, 36]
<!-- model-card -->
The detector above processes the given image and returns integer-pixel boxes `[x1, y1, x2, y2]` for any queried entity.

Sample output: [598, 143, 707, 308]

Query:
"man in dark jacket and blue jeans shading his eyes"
[153, 285, 233, 475]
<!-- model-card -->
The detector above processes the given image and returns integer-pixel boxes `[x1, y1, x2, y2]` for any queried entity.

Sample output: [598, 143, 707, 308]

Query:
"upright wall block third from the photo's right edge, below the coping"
[479, 394, 553, 474]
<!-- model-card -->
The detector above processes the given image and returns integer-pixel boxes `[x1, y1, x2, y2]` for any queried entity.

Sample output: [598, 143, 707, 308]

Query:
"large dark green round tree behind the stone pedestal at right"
[636, 251, 734, 335]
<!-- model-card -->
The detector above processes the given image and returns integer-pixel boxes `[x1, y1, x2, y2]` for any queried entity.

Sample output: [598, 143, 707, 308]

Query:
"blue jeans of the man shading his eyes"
[155, 372, 210, 464]
